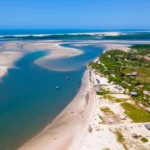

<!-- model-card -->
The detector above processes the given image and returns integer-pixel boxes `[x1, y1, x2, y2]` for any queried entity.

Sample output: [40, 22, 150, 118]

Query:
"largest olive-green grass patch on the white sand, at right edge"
[121, 102, 150, 122]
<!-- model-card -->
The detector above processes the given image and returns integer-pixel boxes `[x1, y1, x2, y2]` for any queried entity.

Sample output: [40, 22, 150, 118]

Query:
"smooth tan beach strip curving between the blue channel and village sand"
[18, 69, 96, 150]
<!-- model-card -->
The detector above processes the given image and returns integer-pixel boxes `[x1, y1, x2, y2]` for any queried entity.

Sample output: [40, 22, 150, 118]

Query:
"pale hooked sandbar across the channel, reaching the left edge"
[0, 41, 83, 78]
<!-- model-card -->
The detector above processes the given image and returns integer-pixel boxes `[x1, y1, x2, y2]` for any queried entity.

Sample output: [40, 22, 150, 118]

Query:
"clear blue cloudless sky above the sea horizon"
[0, 0, 150, 29]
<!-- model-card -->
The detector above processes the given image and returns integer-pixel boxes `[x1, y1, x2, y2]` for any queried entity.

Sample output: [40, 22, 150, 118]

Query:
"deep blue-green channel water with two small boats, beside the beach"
[0, 45, 103, 150]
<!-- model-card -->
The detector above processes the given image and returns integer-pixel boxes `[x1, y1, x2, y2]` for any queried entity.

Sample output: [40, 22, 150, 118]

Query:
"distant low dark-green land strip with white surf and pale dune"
[0, 31, 150, 40]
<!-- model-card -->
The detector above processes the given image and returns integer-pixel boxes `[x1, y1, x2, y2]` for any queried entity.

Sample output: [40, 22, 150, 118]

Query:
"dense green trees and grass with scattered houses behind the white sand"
[89, 45, 150, 106]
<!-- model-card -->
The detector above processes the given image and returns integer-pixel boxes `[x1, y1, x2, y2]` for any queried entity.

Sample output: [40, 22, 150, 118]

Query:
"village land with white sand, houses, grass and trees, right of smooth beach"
[81, 45, 150, 150]
